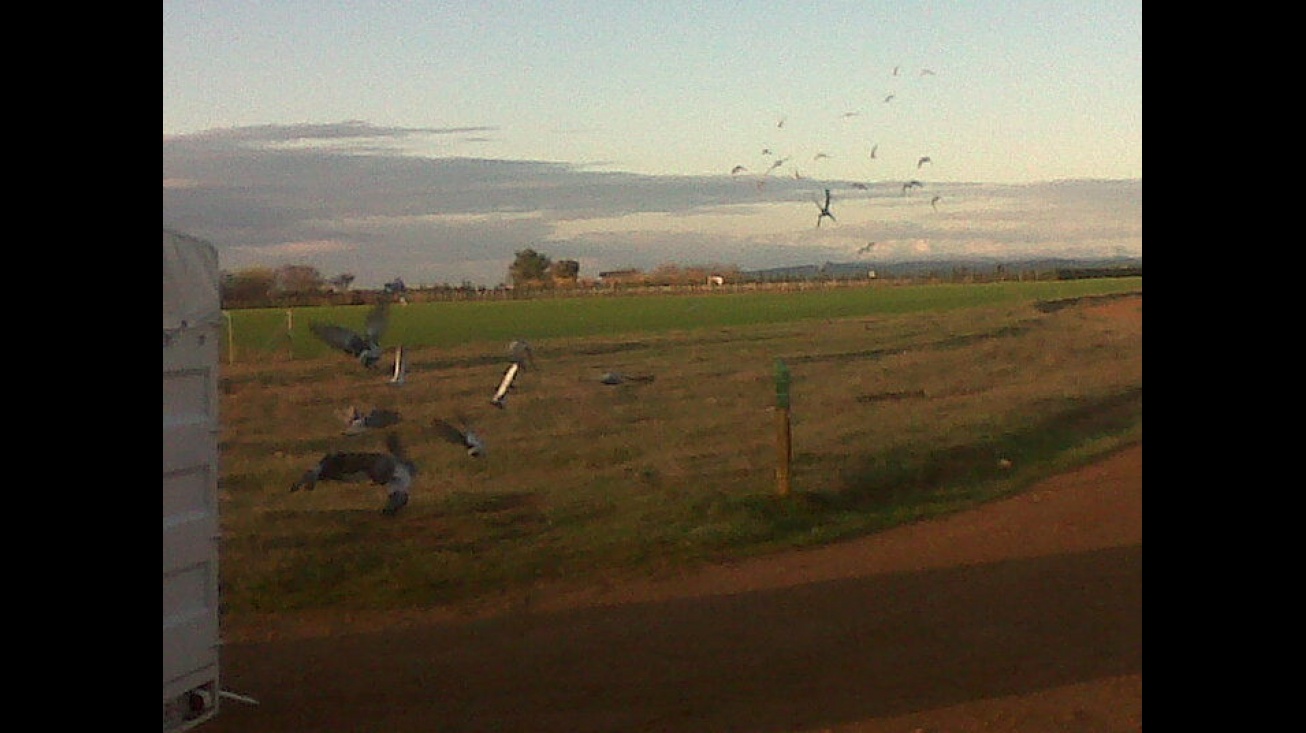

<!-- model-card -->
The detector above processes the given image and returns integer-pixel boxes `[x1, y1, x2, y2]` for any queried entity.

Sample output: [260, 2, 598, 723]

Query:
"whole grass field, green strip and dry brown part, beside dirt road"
[219, 278, 1143, 614]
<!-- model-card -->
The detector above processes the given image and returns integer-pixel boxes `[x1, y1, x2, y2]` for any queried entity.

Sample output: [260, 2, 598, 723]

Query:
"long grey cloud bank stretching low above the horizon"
[163, 122, 1143, 287]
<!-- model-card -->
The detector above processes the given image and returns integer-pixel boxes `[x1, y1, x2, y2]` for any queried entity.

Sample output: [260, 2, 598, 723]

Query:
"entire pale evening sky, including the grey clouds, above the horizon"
[163, 0, 1143, 287]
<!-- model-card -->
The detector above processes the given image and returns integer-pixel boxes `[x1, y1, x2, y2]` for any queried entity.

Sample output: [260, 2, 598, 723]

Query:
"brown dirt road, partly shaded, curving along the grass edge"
[202, 444, 1143, 733]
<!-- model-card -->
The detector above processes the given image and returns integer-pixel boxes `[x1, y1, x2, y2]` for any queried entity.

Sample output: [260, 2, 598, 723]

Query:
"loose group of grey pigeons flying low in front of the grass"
[290, 294, 653, 516]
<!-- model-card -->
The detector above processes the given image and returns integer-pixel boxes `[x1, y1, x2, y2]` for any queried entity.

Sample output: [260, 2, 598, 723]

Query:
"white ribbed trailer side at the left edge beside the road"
[163, 229, 222, 732]
